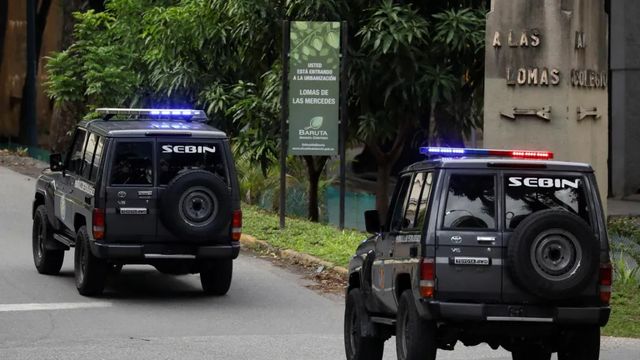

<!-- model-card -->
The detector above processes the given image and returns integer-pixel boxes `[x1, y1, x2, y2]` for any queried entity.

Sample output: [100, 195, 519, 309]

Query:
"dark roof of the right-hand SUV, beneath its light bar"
[403, 157, 593, 172]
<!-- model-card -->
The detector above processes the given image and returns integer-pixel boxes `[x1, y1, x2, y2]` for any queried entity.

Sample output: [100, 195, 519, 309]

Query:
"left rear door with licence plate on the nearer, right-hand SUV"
[436, 170, 502, 302]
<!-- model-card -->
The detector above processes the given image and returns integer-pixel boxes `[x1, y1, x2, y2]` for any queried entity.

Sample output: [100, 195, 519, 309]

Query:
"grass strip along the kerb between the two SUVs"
[242, 204, 367, 266]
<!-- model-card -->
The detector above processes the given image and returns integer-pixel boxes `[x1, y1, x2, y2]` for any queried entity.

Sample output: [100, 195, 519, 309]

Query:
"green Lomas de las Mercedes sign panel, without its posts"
[288, 21, 340, 156]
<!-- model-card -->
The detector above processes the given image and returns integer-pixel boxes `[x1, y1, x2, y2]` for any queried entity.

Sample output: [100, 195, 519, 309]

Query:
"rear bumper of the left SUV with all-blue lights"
[90, 241, 240, 263]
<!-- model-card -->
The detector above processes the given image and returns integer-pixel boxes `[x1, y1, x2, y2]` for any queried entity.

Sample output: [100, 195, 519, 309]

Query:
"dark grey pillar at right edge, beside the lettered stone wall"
[611, 0, 640, 198]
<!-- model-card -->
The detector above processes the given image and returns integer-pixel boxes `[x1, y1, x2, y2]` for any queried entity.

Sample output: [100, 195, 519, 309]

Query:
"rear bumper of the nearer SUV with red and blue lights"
[419, 300, 611, 326]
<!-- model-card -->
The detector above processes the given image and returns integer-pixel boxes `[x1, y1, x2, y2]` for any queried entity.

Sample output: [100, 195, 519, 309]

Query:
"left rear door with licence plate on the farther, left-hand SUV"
[105, 138, 157, 243]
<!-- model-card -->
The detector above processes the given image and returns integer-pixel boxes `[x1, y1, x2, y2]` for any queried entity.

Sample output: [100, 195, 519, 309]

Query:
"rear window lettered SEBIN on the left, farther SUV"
[158, 142, 227, 185]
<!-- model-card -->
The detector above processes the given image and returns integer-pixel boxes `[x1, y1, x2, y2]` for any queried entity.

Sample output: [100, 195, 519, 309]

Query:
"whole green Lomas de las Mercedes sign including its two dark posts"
[280, 21, 347, 229]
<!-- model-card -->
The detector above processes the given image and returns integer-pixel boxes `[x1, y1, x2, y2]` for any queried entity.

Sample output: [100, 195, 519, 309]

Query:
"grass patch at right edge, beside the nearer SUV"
[603, 286, 640, 338]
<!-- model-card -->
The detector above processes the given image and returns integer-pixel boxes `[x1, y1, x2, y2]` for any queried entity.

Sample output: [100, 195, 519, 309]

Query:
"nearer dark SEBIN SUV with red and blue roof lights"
[344, 148, 612, 360]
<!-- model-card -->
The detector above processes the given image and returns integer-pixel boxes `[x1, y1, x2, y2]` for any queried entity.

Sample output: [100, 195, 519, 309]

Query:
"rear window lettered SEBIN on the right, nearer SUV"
[504, 175, 591, 230]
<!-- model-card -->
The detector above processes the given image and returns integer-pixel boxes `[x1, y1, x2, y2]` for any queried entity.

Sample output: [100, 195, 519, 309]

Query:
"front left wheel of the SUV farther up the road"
[31, 205, 64, 275]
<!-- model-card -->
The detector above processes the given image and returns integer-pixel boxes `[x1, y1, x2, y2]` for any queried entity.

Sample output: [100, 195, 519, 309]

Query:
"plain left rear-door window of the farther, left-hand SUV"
[111, 142, 153, 186]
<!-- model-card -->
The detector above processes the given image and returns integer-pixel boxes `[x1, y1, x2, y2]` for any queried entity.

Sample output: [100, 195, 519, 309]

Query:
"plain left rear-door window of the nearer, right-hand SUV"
[443, 174, 496, 229]
